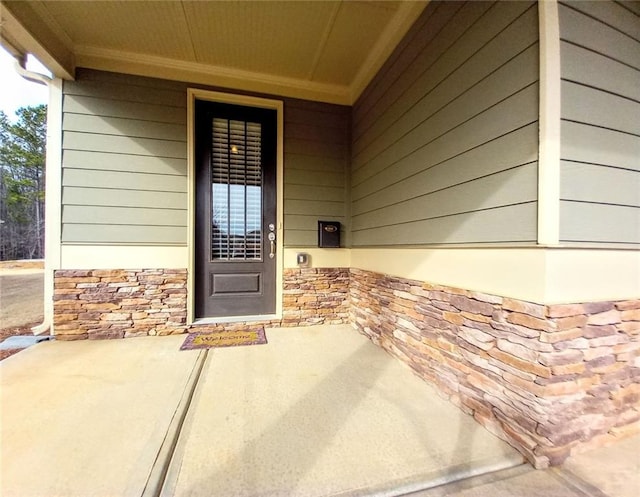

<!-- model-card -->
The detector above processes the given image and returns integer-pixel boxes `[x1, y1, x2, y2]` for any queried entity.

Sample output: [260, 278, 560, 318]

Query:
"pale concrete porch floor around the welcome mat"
[0, 326, 637, 497]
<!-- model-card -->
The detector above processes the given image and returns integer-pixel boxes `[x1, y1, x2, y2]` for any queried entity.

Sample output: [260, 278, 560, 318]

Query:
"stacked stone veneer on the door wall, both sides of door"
[53, 268, 349, 340]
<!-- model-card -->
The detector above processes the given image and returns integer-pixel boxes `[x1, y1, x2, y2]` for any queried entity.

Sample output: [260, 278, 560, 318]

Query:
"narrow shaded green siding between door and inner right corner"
[284, 100, 350, 247]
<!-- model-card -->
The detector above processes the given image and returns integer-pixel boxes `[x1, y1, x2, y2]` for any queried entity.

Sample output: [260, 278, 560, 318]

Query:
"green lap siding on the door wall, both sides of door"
[62, 69, 350, 247]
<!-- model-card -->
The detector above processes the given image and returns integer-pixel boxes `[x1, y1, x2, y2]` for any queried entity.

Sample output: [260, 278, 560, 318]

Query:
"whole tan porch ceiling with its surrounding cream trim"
[1, 0, 427, 104]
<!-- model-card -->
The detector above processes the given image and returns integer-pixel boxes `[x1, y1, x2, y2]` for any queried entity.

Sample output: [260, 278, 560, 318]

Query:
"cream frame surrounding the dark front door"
[187, 88, 284, 325]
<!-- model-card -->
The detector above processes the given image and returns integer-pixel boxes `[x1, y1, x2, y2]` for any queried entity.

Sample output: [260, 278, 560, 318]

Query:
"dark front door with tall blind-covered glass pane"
[195, 101, 277, 318]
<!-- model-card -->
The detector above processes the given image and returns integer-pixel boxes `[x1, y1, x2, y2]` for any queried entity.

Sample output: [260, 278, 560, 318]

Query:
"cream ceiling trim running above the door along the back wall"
[75, 46, 352, 105]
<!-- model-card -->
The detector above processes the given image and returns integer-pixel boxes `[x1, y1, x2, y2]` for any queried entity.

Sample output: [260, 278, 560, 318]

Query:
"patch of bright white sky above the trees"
[0, 47, 49, 120]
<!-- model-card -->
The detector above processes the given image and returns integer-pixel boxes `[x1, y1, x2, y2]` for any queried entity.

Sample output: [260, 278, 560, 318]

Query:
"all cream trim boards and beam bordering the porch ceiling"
[0, 0, 429, 105]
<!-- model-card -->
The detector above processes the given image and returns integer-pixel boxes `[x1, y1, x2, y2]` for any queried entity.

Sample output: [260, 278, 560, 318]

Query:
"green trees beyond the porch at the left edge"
[0, 105, 47, 260]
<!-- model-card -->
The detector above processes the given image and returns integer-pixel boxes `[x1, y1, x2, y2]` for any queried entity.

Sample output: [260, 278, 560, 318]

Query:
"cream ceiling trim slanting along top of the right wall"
[349, 0, 429, 104]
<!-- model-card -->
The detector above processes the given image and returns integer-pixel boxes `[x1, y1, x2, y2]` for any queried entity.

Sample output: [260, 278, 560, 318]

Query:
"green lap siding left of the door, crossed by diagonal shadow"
[62, 69, 187, 244]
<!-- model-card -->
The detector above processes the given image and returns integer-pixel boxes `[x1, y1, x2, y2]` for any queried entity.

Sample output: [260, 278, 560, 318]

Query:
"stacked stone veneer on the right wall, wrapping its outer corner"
[350, 269, 640, 468]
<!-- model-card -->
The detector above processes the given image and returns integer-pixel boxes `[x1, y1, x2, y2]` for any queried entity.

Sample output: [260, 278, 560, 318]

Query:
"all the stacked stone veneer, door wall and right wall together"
[54, 268, 640, 467]
